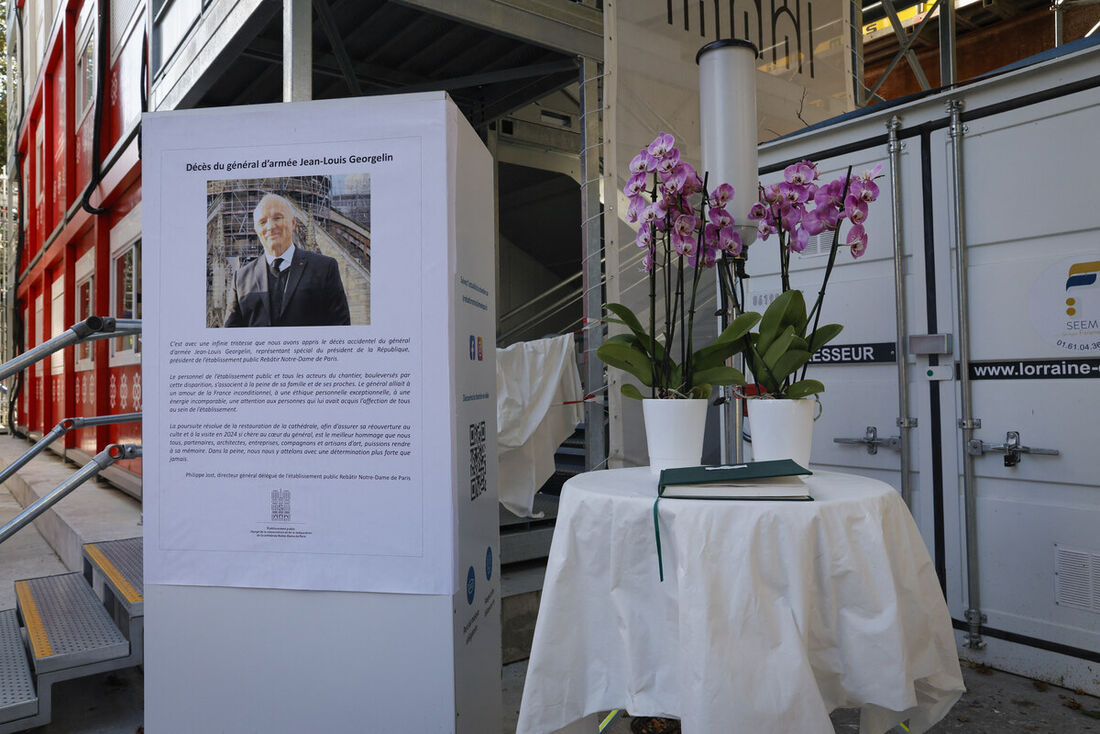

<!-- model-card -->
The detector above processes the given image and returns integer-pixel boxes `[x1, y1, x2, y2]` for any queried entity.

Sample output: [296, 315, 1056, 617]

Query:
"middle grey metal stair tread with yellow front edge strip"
[15, 573, 130, 675]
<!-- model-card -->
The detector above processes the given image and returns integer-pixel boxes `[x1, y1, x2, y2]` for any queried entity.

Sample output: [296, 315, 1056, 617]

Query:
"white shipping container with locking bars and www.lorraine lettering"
[748, 40, 1100, 695]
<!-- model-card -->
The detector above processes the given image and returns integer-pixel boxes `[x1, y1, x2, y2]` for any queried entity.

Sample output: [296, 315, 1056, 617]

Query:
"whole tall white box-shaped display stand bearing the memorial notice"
[143, 92, 501, 734]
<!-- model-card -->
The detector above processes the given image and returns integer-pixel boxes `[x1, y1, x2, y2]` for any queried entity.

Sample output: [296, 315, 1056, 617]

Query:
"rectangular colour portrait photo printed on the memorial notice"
[204, 172, 372, 329]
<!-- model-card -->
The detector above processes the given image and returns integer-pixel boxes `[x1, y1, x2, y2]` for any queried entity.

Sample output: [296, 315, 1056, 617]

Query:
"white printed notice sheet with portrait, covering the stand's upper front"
[144, 96, 495, 594]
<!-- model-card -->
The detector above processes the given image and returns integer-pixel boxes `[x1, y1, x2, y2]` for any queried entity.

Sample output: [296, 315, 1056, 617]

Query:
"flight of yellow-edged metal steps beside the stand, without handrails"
[0, 537, 145, 734]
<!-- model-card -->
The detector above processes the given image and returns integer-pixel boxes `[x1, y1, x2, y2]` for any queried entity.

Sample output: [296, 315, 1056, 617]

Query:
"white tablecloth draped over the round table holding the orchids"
[517, 468, 964, 734]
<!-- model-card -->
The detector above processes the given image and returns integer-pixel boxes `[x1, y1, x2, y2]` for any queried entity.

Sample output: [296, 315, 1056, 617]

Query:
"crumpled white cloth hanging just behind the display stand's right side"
[496, 333, 584, 517]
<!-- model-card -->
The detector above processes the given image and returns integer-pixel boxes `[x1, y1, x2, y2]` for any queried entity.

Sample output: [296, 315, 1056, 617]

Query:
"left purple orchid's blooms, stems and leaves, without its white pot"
[597, 132, 760, 399]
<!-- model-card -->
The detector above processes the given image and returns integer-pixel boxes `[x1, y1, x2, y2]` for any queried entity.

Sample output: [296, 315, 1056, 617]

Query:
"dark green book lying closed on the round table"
[657, 459, 813, 500]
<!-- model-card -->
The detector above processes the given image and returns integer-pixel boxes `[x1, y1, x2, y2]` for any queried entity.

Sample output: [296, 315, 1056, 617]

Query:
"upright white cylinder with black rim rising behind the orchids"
[695, 39, 759, 244]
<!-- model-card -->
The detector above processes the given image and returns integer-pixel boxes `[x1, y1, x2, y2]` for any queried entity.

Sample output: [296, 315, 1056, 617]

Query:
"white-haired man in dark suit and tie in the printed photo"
[223, 194, 351, 327]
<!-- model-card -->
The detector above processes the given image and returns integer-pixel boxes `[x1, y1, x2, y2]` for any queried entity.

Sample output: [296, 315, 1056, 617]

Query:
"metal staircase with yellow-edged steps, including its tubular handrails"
[0, 316, 145, 734]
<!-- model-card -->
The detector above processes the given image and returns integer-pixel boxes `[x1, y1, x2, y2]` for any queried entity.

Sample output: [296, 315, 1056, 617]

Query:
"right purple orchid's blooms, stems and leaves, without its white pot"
[723, 161, 882, 398]
